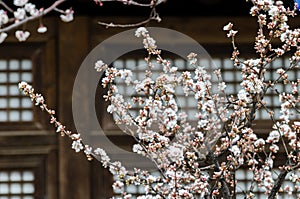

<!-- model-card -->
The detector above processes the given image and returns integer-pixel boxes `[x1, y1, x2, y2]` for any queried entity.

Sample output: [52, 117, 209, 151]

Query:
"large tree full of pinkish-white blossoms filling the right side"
[19, 0, 300, 199]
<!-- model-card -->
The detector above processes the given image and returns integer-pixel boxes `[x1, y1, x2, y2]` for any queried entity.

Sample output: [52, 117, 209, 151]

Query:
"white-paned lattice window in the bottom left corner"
[0, 169, 35, 199]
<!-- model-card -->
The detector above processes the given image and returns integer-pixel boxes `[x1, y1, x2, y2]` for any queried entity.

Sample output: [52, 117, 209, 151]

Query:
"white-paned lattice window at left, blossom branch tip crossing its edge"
[0, 59, 33, 122]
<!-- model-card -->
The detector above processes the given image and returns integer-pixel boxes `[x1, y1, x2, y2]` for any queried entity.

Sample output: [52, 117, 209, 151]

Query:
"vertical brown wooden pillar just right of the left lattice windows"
[58, 17, 91, 199]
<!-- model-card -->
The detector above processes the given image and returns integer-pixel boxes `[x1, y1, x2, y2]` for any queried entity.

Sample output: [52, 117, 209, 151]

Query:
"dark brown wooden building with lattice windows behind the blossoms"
[0, 0, 300, 199]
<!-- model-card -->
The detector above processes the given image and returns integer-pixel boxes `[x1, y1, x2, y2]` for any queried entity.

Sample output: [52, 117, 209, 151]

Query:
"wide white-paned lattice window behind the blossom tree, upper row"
[113, 57, 300, 121]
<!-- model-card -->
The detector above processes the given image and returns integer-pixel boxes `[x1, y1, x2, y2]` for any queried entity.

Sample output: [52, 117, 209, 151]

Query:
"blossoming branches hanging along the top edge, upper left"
[0, 0, 164, 43]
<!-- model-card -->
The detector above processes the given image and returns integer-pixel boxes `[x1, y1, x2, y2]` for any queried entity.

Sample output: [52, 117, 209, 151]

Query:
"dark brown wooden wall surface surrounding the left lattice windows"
[0, 14, 299, 199]
